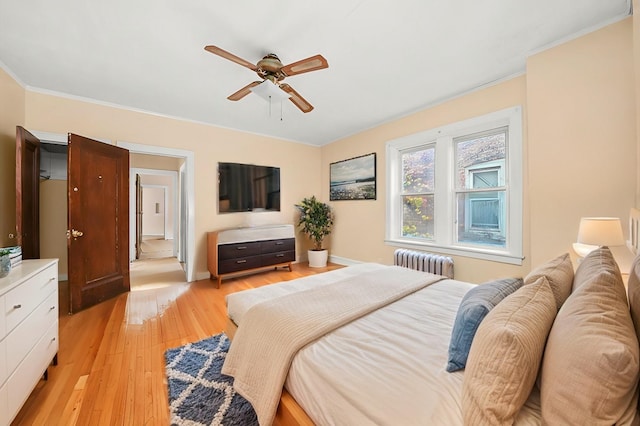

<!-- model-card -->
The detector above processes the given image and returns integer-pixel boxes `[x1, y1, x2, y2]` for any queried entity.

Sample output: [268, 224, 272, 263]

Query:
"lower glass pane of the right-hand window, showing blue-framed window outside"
[457, 191, 506, 247]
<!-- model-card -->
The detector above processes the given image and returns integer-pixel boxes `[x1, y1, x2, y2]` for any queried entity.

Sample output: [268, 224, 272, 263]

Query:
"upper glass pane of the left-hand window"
[402, 147, 436, 194]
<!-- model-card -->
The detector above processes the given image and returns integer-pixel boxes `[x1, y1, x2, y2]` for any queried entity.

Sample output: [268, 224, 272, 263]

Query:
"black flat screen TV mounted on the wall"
[218, 163, 280, 213]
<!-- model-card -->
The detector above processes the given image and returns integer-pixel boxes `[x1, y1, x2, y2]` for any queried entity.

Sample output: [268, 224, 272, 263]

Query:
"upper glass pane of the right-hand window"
[455, 129, 507, 189]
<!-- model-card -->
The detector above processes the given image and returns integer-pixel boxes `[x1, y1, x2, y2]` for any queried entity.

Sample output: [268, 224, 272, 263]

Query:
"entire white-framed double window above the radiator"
[386, 107, 522, 264]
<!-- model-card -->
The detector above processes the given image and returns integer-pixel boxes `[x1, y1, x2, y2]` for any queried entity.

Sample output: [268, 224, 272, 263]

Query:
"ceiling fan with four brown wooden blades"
[204, 46, 329, 112]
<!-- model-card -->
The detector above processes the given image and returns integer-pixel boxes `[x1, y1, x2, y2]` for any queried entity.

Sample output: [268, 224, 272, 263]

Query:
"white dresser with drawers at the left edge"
[0, 259, 58, 426]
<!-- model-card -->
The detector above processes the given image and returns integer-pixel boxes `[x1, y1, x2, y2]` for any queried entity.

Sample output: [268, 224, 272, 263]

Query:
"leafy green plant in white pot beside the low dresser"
[296, 196, 333, 268]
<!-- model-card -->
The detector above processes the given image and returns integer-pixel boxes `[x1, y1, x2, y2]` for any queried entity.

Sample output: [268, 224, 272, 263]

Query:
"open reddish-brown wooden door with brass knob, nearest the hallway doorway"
[67, 134, 129, 312]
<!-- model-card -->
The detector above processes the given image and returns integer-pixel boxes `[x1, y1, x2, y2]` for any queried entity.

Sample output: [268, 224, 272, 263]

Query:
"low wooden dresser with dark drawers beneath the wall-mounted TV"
[207, 225, 296, 288]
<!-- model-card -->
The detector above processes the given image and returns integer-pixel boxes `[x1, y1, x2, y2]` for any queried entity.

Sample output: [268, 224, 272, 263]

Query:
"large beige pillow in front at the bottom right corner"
[540, 270, 640, 425]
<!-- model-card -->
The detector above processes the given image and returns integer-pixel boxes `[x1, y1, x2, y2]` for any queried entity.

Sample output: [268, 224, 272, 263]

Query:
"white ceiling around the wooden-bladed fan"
[0, 0, 630, 145]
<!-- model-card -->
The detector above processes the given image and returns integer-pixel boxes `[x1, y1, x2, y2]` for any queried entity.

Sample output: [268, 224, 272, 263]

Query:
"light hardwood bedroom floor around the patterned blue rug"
[12, 263, 341, 425]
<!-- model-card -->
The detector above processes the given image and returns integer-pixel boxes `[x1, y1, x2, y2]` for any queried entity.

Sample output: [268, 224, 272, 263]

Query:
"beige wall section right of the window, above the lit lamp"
[527, 18, 638, 265]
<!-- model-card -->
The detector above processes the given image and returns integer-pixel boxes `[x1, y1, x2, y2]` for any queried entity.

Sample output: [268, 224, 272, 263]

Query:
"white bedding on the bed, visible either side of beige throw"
[227, 264, 540, 425]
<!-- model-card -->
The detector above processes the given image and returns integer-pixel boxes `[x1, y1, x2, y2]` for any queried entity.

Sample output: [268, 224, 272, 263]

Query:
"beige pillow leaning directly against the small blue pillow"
[462, 276, 557, 425]
